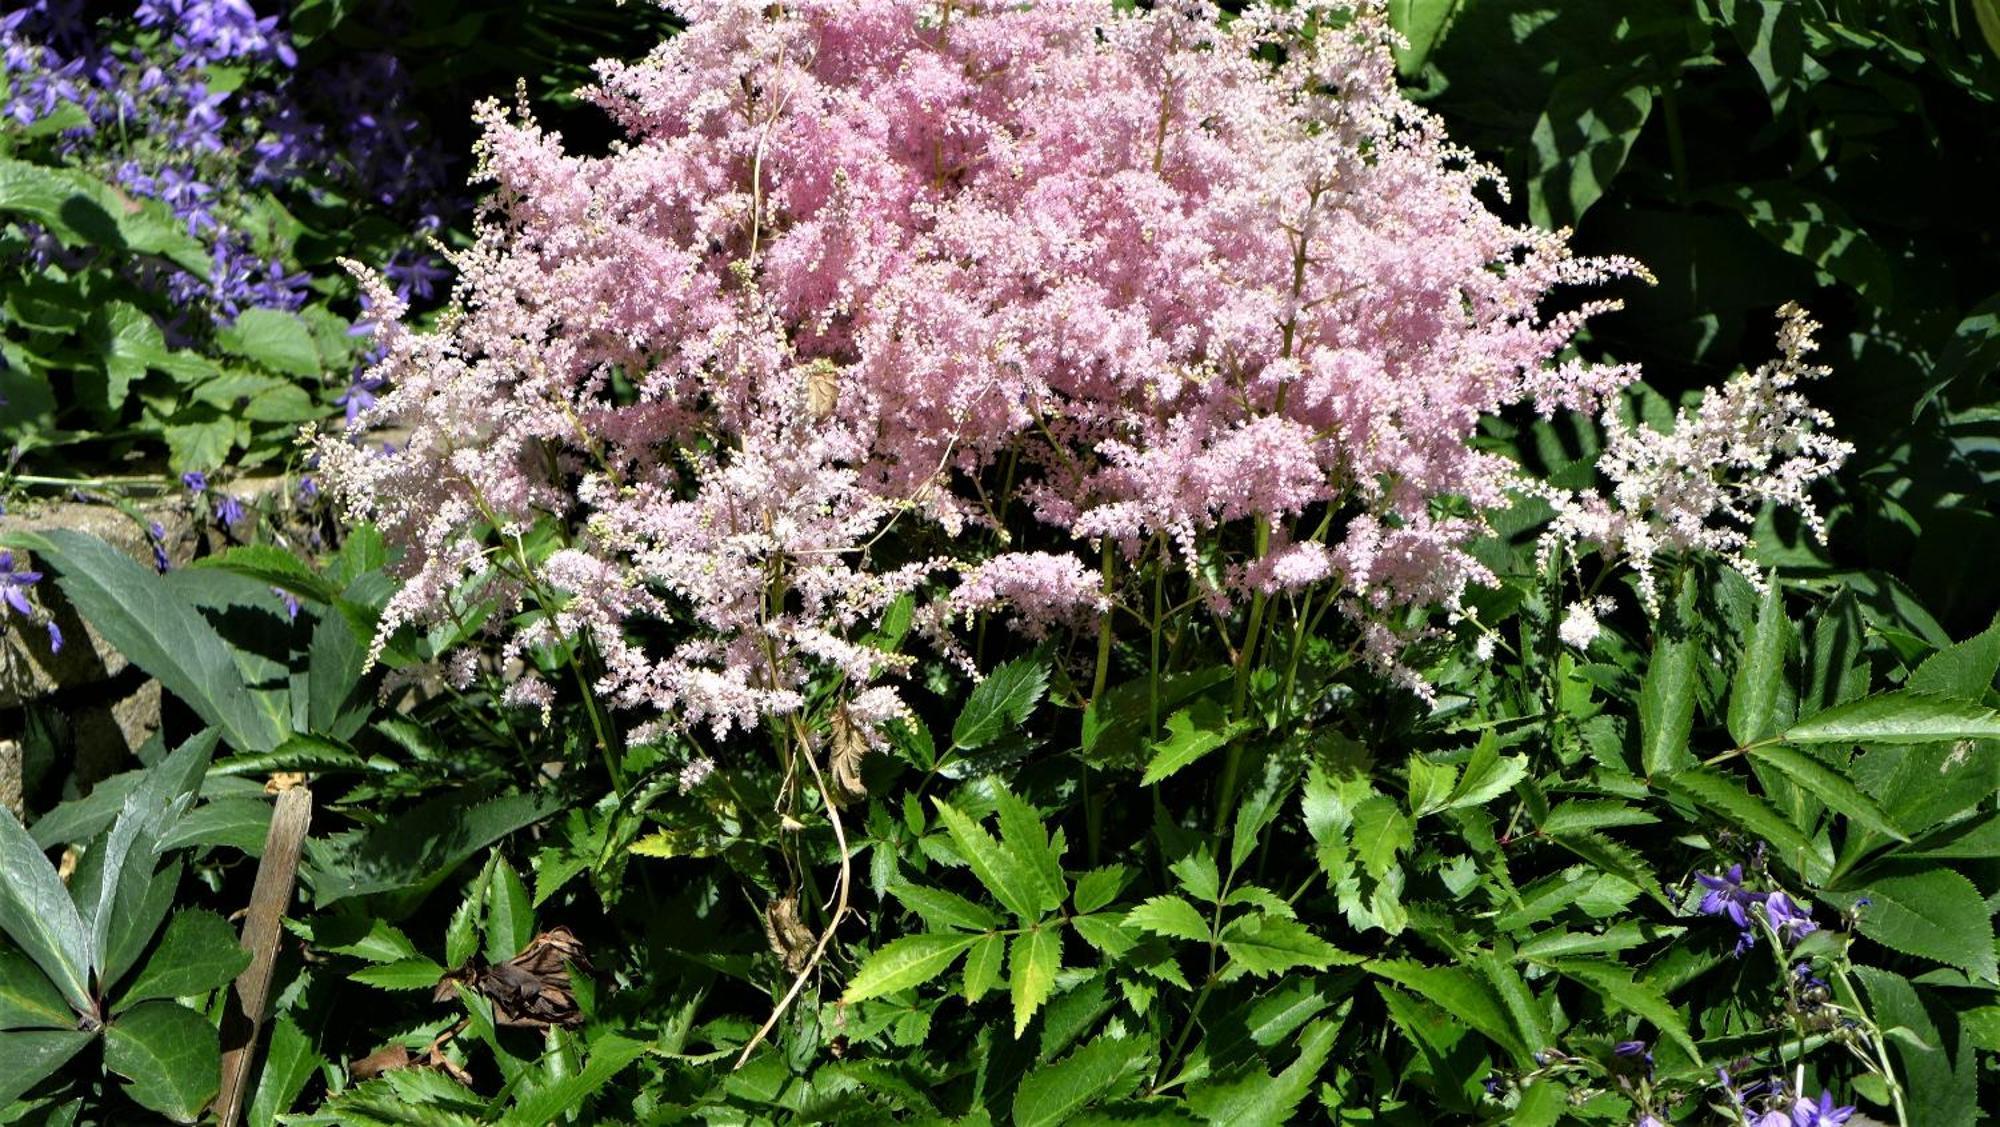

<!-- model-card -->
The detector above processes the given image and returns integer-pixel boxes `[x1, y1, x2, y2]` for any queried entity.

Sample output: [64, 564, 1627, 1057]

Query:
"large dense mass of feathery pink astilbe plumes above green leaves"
[318, 0, 1832, 731]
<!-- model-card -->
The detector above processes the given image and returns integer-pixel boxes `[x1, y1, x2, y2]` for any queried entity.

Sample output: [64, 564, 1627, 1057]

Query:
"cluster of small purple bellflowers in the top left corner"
[0, 0, 446, 329]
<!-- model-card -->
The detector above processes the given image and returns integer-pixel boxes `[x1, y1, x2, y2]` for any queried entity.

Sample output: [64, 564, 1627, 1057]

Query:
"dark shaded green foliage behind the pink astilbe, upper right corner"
[1392, 0, 2000, 635]
